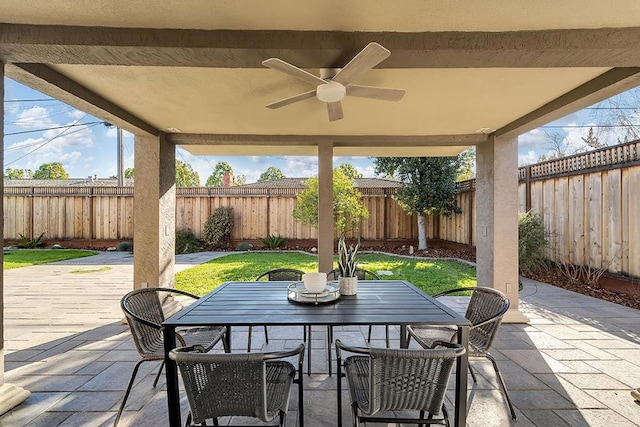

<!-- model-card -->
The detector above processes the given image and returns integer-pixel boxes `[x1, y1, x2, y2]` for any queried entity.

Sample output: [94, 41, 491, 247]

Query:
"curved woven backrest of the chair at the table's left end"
[120, 288, 182, 358]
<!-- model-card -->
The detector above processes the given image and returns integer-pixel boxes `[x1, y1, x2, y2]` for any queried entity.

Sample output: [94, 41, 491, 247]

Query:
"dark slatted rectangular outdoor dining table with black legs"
[162, 280, 471, 427]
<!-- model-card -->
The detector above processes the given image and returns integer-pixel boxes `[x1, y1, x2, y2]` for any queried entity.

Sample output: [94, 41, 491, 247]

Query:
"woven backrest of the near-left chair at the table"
[169, 345, 304, 424]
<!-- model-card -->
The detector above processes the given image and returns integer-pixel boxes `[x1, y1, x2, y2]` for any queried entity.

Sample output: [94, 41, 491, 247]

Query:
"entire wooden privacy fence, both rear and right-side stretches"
[4, 141, 640, 277]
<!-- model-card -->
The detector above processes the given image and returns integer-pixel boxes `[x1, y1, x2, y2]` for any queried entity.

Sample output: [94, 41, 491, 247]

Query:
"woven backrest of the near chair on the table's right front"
[364, 347, 464, 415]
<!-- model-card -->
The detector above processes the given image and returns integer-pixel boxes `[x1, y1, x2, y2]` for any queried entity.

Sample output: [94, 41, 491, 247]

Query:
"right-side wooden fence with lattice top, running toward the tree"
[435, 141, 640, 277]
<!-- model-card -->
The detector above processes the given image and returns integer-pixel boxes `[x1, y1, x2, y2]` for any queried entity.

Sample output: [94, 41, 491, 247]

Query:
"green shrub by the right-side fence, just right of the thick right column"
[518, 212, 549, 273]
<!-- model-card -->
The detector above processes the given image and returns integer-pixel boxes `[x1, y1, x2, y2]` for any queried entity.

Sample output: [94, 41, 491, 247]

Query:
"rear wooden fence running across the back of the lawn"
[4, 187, 418, 246]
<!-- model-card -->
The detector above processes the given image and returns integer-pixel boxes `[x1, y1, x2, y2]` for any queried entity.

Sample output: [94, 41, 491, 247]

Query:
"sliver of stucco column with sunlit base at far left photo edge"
[0, 62, 31, 415]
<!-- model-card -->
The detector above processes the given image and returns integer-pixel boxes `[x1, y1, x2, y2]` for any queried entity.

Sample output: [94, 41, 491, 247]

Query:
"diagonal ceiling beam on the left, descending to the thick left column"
[6, 64, 159, 136]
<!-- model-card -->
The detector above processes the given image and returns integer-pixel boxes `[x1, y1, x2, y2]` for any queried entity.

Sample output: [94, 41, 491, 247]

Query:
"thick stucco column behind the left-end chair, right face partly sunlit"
[133, 133, 176, 289]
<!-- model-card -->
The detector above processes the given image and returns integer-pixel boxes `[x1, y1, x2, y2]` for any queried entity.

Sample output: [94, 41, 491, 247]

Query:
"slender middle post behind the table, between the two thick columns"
[318, 142, 334, 273]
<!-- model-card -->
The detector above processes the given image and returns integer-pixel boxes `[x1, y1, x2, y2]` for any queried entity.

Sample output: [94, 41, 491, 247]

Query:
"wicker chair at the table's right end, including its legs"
[407, 287, 516, 420]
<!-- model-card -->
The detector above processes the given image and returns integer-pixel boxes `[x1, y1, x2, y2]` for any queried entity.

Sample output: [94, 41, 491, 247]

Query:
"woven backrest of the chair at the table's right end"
[465, 287, 509, 355]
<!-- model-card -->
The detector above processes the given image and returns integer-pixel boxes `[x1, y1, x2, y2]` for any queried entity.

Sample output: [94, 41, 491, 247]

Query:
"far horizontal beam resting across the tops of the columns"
[167, 133, 488, 148]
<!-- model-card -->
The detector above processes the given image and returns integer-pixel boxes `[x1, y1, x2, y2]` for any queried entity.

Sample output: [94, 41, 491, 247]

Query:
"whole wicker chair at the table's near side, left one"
[169, 344, 304, 426]
